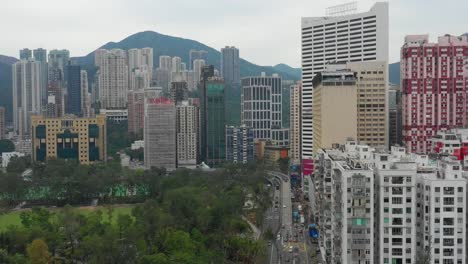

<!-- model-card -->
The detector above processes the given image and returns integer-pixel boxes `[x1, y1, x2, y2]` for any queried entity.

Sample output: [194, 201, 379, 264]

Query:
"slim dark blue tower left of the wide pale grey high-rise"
[65, 63, 82, 116]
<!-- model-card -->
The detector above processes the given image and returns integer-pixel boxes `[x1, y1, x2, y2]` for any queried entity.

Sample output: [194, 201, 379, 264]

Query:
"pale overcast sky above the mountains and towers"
[0, 0, 468, 67]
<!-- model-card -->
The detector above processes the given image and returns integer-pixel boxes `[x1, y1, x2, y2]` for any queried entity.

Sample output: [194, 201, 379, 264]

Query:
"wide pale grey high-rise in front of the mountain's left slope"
[95, 49, 128, 109]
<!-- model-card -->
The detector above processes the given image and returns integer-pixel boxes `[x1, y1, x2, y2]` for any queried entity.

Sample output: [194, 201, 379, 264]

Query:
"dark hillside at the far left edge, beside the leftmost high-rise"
[0, 55, 18, 121]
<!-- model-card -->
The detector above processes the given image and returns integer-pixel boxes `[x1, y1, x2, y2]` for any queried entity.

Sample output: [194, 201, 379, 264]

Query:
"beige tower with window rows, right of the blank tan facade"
[346, 61, 388, 147]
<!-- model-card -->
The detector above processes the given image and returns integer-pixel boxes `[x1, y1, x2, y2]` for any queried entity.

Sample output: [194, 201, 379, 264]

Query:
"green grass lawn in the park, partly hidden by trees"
[0, 205, 134, 231]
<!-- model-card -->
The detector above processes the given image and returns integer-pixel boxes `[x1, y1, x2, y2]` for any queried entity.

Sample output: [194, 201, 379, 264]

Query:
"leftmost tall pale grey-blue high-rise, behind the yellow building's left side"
[12, 60, 42, 139]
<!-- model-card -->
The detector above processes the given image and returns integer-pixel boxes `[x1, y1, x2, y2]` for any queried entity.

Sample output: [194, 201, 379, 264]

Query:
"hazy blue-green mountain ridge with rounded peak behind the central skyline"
[72, 31, 300, 80]
